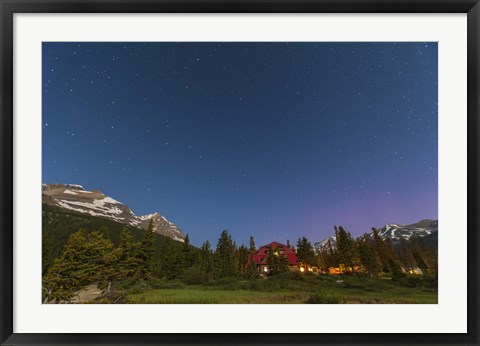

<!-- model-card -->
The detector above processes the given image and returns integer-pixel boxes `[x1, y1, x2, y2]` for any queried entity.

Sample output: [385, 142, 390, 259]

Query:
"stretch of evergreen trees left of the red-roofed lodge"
[42, 223, 259, 303]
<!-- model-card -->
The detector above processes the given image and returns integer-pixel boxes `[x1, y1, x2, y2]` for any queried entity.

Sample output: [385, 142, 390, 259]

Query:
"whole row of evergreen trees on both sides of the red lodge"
[42, 223, 437, 303]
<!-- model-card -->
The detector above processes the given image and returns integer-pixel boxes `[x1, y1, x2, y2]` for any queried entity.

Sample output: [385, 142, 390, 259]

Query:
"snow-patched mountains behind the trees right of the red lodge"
[314, 219, 438, 251]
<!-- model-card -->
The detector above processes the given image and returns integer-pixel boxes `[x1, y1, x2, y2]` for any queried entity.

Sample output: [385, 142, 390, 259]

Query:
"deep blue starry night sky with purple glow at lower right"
[42, 42, 438, 246]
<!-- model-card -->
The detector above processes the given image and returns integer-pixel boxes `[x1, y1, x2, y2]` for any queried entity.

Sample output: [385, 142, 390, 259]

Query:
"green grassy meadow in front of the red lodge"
[125, 276, 438, 304]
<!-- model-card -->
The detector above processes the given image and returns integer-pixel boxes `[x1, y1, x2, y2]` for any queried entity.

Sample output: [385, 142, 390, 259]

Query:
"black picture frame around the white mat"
[0, 0, 480, 345]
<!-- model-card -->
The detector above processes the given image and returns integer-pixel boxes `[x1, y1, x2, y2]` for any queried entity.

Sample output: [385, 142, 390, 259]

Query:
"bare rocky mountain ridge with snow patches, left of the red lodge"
[42, 184, 185, 242]
